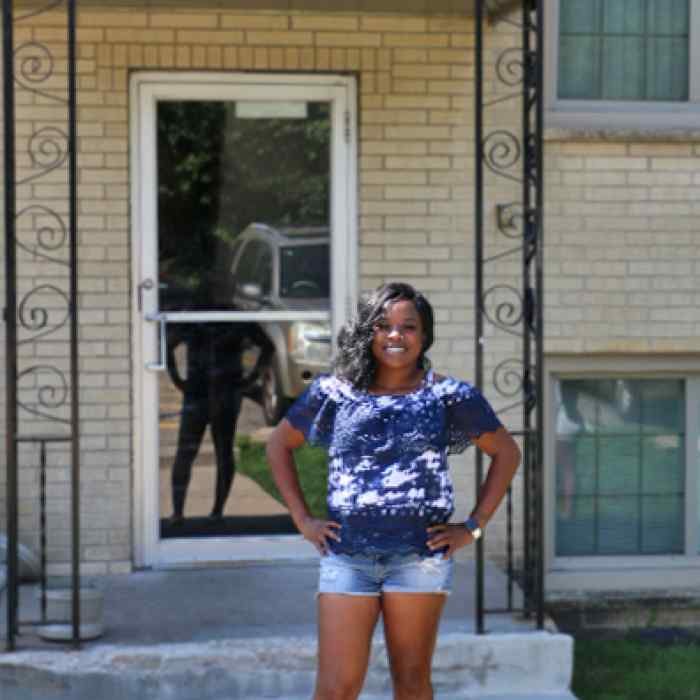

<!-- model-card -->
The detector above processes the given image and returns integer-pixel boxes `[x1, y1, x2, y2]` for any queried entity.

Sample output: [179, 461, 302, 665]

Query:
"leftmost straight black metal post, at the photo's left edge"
[2, 0, 19, 651]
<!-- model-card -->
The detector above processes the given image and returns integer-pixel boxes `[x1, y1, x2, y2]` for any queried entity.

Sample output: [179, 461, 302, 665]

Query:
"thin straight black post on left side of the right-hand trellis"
[474, 0, 484, 634]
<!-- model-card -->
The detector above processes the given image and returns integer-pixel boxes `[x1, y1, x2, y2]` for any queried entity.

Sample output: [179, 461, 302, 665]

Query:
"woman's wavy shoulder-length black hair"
[333, 282, 435, 389]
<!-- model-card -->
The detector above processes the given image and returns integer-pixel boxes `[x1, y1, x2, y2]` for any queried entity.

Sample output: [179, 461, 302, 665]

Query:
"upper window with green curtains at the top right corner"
[547, 0, 700, 128]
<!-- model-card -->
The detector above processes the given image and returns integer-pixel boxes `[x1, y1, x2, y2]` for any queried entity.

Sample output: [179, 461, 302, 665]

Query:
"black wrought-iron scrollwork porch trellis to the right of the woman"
[474, 0, 544, 634]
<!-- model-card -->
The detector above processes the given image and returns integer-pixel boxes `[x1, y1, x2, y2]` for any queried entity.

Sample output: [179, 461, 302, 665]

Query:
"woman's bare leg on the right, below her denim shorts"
[382, 593, 445, 700]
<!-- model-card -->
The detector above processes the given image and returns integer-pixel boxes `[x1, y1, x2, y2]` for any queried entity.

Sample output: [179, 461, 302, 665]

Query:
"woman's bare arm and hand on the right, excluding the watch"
[428, 427, 521, 557]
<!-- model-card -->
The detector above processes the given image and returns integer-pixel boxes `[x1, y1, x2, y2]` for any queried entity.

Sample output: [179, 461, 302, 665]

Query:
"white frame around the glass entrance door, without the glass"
[130, 71, 357, 567]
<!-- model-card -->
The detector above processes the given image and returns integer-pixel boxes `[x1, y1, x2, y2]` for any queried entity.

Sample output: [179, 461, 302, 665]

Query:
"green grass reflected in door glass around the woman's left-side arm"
[236, 436, 328, 518]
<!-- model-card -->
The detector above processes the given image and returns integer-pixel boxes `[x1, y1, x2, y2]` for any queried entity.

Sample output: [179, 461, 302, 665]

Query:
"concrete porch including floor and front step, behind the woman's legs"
[0, 561, 573, 700]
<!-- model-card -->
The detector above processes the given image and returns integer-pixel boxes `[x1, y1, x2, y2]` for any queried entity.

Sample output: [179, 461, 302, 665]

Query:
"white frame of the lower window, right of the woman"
[543, 355, 700, 591]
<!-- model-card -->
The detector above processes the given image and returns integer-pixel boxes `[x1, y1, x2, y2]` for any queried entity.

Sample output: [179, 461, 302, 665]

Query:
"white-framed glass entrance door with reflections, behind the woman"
[134, 75, 354, 565]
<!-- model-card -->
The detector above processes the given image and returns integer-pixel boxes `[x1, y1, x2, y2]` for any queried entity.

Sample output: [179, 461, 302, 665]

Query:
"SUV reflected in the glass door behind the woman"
[231, 223, 332, 425]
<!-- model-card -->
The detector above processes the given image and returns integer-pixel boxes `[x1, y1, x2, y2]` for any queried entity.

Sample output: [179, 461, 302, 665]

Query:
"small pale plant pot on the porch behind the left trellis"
[37, 588, 104, 642]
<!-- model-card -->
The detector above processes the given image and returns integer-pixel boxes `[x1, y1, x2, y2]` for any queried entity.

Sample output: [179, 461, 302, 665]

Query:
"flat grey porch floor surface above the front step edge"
[6, 560, 532, 649]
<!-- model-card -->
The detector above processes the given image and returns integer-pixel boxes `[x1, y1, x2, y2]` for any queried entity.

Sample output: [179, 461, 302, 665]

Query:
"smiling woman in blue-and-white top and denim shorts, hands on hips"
[267, 283, 520, 700]
